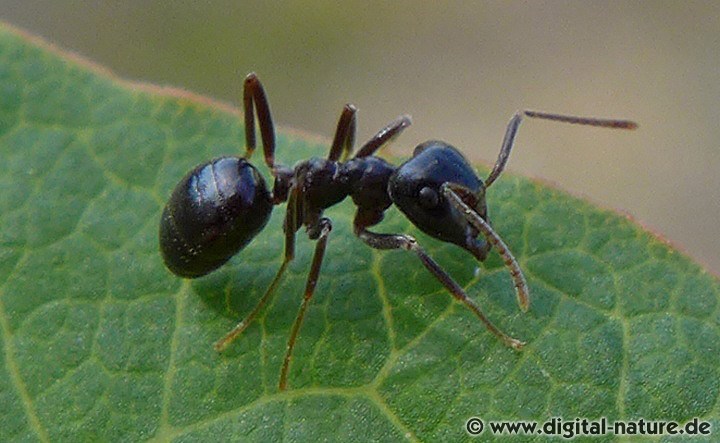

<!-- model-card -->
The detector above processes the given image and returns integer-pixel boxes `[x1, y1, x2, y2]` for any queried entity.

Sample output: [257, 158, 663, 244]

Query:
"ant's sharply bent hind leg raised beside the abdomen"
[243, 72, 275, 170]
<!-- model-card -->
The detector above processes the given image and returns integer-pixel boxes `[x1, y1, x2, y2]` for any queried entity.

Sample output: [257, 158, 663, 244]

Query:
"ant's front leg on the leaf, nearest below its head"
[354, 212, 525, 350]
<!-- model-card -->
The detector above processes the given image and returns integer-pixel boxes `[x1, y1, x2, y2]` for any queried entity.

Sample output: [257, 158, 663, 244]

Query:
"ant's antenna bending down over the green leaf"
[442, 183, 530, 312]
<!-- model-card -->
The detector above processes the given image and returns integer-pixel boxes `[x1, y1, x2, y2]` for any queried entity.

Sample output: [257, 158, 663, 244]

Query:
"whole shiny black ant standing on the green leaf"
[160, 73, 637, 390]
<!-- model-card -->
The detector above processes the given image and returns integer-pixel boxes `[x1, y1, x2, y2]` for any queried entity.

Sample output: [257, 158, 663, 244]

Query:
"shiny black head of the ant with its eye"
[388, 141, 487, 256]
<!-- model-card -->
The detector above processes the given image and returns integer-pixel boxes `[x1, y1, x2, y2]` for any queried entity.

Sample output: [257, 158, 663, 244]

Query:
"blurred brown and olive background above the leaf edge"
[0, 0, 720, 274]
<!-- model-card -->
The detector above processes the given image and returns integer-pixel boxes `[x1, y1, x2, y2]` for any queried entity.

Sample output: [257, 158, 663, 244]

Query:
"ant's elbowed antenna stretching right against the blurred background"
[485, 109, 637, 188]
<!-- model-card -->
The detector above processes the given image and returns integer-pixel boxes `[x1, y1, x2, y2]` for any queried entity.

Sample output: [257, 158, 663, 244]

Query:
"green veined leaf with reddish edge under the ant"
[0, 27, 720, 441]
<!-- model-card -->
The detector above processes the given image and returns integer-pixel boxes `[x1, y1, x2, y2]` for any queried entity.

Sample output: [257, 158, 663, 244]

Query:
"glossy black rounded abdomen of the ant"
[160, 157, 273, 278]
